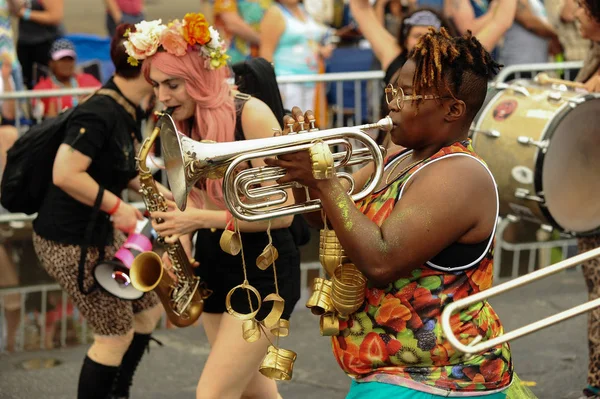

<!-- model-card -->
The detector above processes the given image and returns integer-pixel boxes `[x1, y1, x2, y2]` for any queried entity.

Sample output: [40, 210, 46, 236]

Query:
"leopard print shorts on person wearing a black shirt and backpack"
[33, 232, 159, 336]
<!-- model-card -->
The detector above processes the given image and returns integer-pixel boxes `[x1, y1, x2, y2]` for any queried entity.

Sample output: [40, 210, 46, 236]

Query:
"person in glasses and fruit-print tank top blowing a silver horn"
[266, 29, 530, 399]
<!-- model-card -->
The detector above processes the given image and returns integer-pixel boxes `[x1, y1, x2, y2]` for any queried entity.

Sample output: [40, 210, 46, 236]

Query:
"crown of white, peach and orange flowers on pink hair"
[124, 13, 229, 69]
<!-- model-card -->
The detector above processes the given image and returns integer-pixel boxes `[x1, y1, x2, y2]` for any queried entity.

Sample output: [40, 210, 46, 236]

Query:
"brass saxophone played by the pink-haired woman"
[129, 110, 210, 327]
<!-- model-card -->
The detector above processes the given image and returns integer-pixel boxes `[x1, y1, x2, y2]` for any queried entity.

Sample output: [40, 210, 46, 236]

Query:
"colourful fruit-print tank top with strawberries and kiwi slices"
[332, 140, 513, 396]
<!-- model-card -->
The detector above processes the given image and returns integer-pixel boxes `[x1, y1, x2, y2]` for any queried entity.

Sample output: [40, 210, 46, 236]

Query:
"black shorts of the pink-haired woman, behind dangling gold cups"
[195, 229, 300, 320]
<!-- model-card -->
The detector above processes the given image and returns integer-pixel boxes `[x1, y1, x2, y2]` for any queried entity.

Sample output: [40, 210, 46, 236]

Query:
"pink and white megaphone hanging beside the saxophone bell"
[93, 219, 158, 301]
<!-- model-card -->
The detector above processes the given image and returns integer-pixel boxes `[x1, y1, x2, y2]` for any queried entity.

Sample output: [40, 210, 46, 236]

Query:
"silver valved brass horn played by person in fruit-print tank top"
[159, 115, 393, 222]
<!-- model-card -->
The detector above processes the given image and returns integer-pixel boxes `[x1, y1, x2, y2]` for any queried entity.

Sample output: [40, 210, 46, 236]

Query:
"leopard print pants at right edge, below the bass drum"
[578, 235, 600, 387]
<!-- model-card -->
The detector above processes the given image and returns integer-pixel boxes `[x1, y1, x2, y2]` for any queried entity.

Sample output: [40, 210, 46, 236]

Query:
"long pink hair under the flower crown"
[143, 51, 236, 209]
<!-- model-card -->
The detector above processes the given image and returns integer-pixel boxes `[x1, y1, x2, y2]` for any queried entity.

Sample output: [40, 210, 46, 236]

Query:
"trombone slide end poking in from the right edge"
[442, 247, 600, 355]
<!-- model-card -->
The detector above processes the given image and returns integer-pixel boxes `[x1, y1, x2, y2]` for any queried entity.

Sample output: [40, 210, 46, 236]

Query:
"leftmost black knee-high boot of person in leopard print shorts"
[77, 356, 119, 399]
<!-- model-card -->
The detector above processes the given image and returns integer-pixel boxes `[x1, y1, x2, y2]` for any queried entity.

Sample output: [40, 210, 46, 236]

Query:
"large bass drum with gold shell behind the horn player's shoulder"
[471, 81, 600, 236]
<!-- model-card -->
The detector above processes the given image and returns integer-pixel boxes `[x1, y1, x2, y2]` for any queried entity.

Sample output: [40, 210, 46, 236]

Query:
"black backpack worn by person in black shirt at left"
[0, 108, 75, 215]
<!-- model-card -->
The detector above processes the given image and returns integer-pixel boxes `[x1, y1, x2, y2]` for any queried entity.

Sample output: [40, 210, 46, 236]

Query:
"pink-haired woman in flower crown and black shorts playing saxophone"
[125, 14, 300, 399]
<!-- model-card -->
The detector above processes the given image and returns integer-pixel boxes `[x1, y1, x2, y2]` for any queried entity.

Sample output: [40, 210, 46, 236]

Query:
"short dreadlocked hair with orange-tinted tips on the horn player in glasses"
[409, 27, 501, 117]
